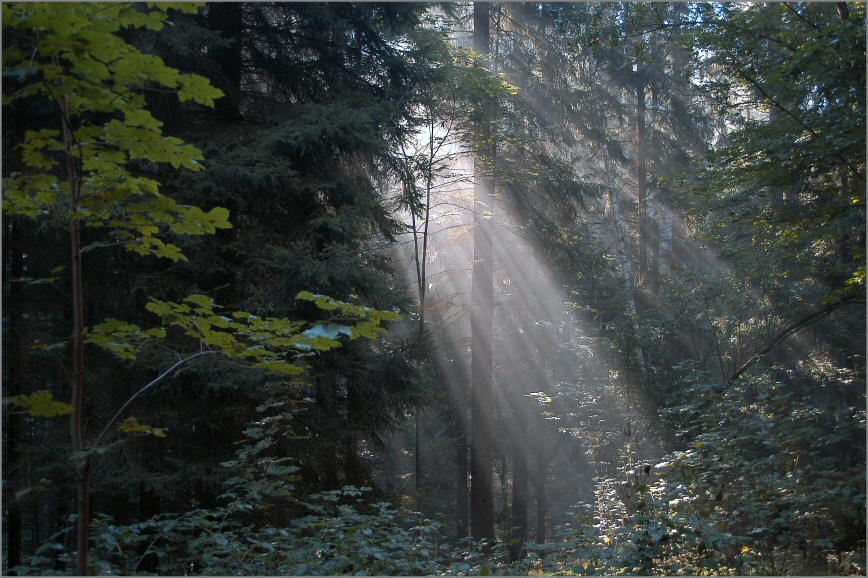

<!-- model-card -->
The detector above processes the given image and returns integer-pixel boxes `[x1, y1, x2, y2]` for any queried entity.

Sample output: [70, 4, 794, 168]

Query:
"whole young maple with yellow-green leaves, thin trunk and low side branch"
[3, 4, 394, 575]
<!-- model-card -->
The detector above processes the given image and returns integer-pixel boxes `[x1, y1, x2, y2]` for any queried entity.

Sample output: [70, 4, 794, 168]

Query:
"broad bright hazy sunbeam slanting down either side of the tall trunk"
[401, 121, 680, 524]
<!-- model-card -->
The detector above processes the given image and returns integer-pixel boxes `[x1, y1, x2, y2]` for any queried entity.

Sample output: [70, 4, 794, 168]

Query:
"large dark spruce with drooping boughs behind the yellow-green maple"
[132, 3, 444, 504]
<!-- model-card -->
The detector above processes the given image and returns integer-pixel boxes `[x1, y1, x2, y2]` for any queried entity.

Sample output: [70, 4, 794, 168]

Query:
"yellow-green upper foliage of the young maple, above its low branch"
[3, 2, 231, 261]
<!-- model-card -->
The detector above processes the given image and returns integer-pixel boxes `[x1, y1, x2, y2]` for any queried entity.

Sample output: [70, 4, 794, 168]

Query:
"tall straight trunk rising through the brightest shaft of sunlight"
[470, 2, 494, 542]
